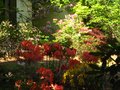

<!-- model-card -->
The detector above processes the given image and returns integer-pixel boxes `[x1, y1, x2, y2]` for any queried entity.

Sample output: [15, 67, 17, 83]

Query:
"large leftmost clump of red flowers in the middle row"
[16, 40, 43, 61]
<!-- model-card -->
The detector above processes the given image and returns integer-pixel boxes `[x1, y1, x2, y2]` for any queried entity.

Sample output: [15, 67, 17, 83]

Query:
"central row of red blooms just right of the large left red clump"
[43, 43, 76, 59]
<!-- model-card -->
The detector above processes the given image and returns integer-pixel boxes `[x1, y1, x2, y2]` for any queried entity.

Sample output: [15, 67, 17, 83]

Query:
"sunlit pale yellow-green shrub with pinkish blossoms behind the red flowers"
[53, 14, 96, 55]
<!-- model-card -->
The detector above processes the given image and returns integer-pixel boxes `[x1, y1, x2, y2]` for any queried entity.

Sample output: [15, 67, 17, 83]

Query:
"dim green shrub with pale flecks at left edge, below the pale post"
[0, 21, 49, 56]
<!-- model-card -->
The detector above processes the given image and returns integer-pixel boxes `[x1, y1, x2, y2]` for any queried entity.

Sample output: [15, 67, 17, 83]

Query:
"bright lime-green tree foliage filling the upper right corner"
[52, 0, 120, 41]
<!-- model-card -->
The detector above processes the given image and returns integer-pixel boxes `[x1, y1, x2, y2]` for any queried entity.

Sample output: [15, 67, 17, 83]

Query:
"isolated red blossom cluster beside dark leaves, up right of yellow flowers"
[82, 52, 98, 62]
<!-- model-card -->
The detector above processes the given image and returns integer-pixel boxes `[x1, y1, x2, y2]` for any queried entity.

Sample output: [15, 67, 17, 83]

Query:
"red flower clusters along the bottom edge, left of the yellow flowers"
[15, 67, 63, 90]
